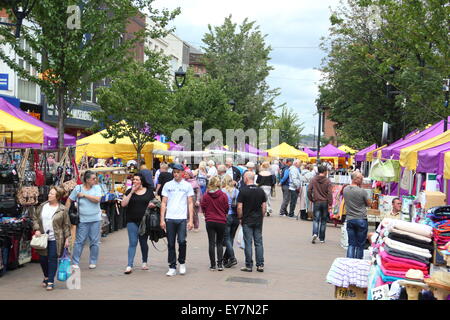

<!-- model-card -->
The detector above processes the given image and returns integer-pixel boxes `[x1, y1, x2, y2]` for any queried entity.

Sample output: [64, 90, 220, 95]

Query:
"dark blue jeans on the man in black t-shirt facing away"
[242, 223, 264, 269]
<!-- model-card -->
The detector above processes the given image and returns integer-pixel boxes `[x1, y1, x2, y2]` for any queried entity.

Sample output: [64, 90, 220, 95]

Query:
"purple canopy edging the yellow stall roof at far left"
[0, 98, 76, 150]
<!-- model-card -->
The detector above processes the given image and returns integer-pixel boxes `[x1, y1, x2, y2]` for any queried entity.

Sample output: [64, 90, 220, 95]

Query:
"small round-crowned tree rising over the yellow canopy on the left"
[93, 62, 176, 162]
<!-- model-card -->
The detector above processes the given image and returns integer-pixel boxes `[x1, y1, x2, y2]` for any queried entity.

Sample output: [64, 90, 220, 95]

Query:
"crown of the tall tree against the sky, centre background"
[203, 15, 279, 130]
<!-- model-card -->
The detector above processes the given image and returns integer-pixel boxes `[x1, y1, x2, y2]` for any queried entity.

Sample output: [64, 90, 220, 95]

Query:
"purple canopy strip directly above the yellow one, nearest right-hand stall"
[381, 117, 450, 160]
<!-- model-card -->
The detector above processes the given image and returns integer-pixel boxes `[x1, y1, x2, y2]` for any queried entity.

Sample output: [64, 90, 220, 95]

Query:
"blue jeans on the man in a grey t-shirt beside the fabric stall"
[347, 219, 369, 259]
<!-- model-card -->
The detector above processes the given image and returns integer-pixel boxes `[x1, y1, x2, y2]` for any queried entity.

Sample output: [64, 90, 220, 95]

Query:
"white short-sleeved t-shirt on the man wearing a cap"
[161, 179, 194, 219]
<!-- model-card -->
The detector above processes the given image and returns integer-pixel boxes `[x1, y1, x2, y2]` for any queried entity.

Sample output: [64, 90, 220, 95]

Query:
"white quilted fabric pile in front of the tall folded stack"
[327, 258, 371, 288]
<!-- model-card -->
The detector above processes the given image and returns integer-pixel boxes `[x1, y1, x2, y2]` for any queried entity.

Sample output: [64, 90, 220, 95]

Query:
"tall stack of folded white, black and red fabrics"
[376, 219, 433, 286]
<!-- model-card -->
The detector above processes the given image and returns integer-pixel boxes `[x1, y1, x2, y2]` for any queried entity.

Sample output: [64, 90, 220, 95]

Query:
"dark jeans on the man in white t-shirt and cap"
[166, 219, 187, 269]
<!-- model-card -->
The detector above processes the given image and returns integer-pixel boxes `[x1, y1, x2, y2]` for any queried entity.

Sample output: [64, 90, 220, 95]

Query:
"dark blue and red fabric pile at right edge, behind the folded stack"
[426, 206, 450, 246]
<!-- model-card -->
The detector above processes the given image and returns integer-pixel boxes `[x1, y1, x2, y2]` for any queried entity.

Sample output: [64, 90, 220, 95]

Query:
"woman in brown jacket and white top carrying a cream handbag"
[33, 187, 71, 291]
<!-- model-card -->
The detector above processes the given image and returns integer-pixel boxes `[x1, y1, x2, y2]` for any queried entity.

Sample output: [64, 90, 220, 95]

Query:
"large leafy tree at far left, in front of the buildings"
[0, 0, 179, 150]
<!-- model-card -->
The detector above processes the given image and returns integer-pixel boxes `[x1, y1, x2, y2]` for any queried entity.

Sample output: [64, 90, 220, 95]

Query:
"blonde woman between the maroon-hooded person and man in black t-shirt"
[222, 174, 239, 268]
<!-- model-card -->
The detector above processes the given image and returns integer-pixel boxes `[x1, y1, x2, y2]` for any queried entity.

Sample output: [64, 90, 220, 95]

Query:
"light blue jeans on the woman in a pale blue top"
[72, 221, 101, 265]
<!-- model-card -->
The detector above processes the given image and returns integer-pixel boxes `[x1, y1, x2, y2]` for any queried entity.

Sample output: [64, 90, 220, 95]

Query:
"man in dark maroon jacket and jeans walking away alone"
[308, 165, 333, 243]
